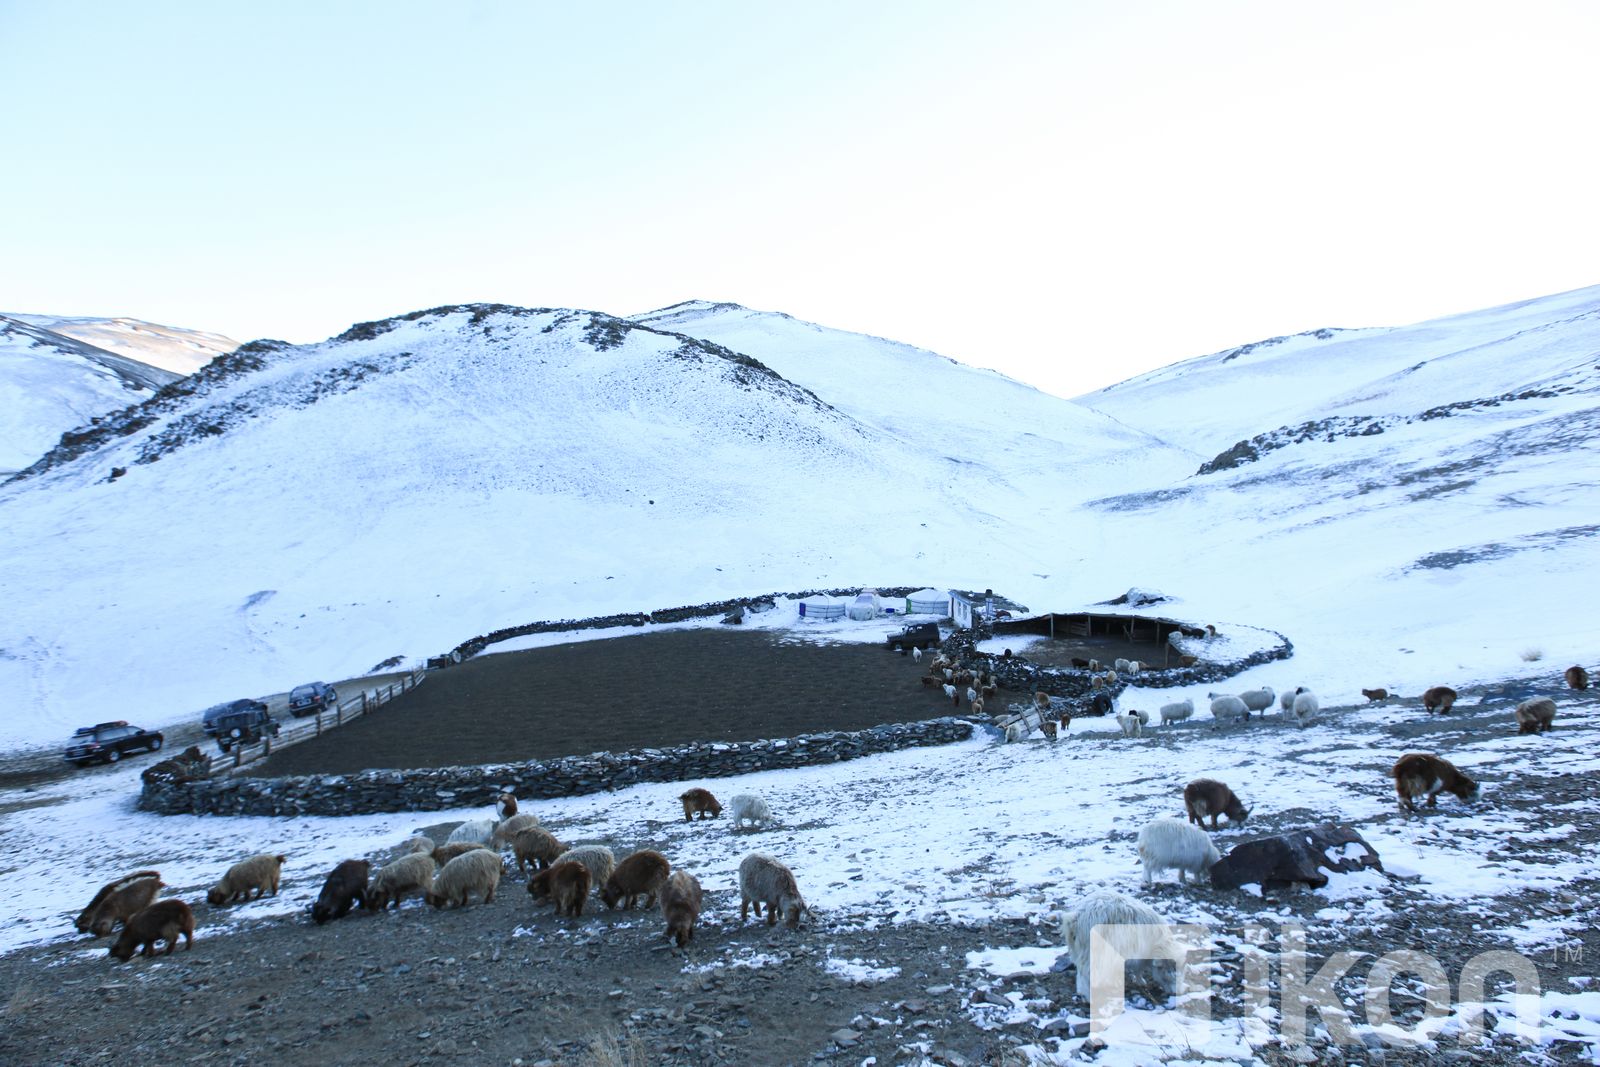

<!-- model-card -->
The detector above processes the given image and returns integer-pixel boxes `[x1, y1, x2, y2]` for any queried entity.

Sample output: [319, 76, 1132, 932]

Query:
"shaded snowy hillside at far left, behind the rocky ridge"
[0, 315, 179, 475]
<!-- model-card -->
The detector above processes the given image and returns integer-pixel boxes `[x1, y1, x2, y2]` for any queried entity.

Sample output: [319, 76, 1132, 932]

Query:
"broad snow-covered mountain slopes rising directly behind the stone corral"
[0, 290, 1600, 747]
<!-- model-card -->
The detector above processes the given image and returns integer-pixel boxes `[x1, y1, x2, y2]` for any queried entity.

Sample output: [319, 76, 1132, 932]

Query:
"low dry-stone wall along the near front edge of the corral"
[139, 718, 973, 816]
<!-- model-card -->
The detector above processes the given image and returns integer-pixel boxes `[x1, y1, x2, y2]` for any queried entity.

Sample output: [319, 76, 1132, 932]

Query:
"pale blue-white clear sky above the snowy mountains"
[0, 0, 1600, 397]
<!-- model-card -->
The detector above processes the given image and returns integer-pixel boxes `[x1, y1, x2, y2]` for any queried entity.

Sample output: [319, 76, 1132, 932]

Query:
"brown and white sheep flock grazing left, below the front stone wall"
[68, 787, 810, 961]
